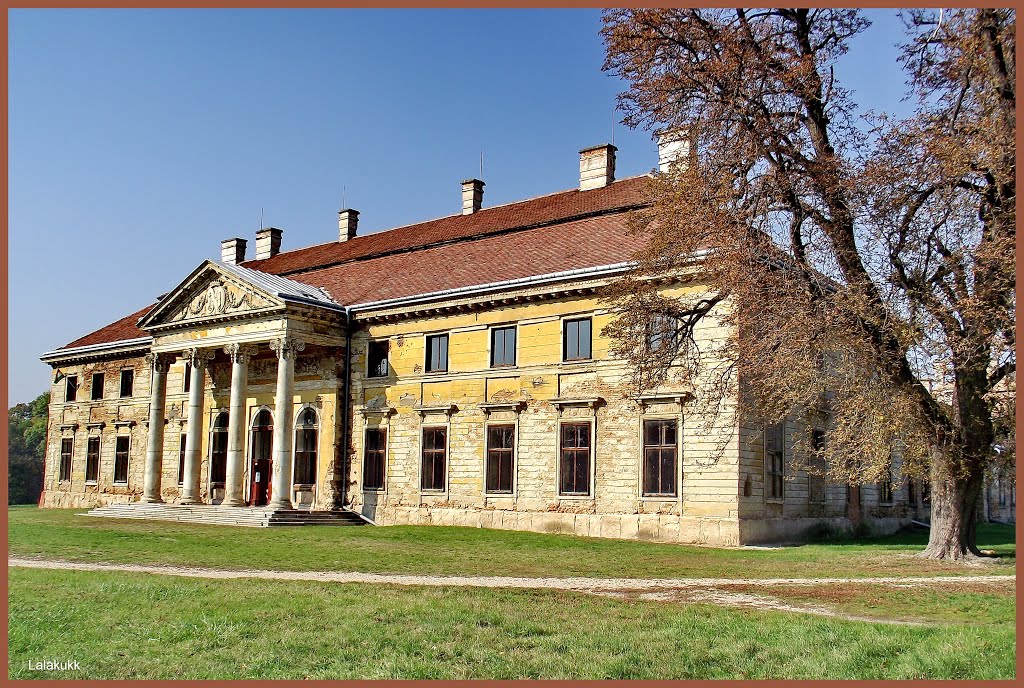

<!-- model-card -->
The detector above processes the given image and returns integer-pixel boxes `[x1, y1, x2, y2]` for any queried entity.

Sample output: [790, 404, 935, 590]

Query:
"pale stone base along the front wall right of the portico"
[362, 506, 740, 547]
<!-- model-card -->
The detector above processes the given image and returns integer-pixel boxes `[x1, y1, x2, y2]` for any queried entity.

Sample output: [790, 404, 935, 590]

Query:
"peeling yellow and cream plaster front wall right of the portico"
[347, 286, 738, 545]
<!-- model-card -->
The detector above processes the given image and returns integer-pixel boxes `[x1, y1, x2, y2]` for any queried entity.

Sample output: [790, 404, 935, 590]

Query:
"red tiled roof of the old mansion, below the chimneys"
[54, 175, 647, 348]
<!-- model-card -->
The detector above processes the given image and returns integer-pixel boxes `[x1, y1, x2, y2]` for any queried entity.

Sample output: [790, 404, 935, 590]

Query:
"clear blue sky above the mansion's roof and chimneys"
[8, 9, 906, 403]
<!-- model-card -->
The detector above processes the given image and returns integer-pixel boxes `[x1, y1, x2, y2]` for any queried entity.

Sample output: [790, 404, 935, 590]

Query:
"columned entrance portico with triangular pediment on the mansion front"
[132, 261, 345, 509]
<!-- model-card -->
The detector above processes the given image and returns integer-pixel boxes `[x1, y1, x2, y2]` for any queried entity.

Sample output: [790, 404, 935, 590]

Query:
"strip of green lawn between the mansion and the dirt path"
[7, 507, 1016, 578]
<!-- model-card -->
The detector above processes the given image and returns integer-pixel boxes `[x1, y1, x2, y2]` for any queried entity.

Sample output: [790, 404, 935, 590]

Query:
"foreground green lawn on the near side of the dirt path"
[8, 565, 1016, 679]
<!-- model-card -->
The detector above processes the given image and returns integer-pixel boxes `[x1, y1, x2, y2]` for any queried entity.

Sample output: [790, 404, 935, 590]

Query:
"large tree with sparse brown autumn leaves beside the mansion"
[602, 9, 1016, 559]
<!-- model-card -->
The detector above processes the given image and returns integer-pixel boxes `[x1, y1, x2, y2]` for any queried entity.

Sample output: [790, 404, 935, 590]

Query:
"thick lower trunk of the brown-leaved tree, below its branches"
[921, 466, 984, 560]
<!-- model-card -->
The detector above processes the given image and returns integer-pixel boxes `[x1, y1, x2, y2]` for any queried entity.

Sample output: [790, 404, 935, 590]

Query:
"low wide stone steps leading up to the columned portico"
[85, 502, 367, 528]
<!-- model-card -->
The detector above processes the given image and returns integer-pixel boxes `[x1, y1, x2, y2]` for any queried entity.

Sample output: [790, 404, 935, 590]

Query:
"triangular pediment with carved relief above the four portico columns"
[138, 260, 286, 330]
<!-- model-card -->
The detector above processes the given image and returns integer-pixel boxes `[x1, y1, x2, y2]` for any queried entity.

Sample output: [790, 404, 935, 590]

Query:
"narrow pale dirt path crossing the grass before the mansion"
[7, 557, 1016, 625]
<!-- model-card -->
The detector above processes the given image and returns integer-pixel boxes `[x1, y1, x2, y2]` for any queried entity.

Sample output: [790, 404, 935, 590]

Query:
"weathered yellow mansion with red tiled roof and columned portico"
[40, 140, 928, 545]
